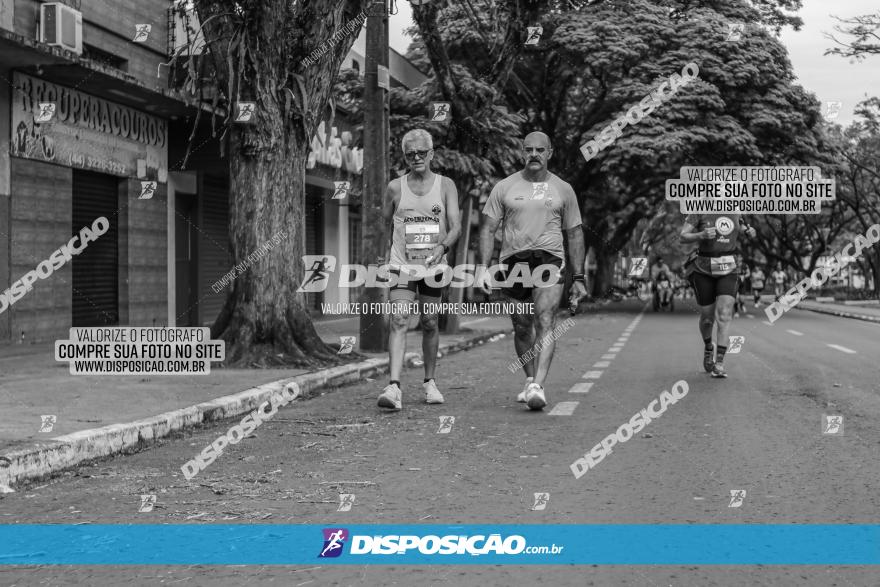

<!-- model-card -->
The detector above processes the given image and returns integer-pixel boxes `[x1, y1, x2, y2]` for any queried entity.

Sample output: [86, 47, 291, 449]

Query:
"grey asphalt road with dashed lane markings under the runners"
[0, 300, 880, 587]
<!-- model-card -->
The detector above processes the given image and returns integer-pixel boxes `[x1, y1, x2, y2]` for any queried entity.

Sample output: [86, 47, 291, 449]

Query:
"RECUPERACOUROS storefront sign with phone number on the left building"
[10, 72, 168, 182]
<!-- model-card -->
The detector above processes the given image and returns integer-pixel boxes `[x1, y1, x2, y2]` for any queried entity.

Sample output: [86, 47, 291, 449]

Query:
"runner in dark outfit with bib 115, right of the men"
[681, 214, 755, 377]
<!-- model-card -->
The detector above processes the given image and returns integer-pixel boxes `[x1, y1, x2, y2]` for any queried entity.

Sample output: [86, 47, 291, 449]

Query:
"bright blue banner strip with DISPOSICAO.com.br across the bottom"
[0, 524, 880, 565]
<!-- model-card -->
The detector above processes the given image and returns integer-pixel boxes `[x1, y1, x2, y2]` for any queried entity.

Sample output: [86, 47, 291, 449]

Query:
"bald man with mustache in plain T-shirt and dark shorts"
[475, 132, 587, 410]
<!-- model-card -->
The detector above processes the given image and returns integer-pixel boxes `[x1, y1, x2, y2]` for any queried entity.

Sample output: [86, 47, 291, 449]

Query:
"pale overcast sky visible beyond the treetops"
[389, 0, 880, 125]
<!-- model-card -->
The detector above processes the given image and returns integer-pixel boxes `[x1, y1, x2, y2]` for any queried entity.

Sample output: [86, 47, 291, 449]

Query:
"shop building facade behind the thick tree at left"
[0, 0, 424, 343]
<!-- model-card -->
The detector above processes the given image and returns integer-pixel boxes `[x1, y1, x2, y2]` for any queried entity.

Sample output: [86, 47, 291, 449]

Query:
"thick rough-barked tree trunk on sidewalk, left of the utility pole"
[177, 0, 368, 366]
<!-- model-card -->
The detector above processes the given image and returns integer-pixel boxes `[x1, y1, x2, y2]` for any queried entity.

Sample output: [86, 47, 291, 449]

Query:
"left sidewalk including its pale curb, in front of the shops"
[0, 317, 511, 490]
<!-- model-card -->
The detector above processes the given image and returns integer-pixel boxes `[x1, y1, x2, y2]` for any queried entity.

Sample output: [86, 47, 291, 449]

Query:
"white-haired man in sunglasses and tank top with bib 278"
[379, 128, 461, 410]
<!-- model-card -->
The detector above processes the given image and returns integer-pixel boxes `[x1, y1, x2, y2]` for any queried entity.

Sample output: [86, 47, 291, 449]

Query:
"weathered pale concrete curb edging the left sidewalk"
[0, 329, 510, 493]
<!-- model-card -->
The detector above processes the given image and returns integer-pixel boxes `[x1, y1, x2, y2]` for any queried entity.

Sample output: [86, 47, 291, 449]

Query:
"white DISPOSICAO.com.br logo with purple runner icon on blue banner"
[318, 528, 565, 558]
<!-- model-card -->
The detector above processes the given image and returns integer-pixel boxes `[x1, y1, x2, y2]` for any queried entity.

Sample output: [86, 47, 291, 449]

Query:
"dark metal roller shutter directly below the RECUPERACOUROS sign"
[71, 171, 119, 327]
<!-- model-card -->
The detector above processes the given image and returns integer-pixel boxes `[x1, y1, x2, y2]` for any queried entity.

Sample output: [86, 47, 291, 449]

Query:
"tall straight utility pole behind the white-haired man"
[360, 0, 389, 352]
